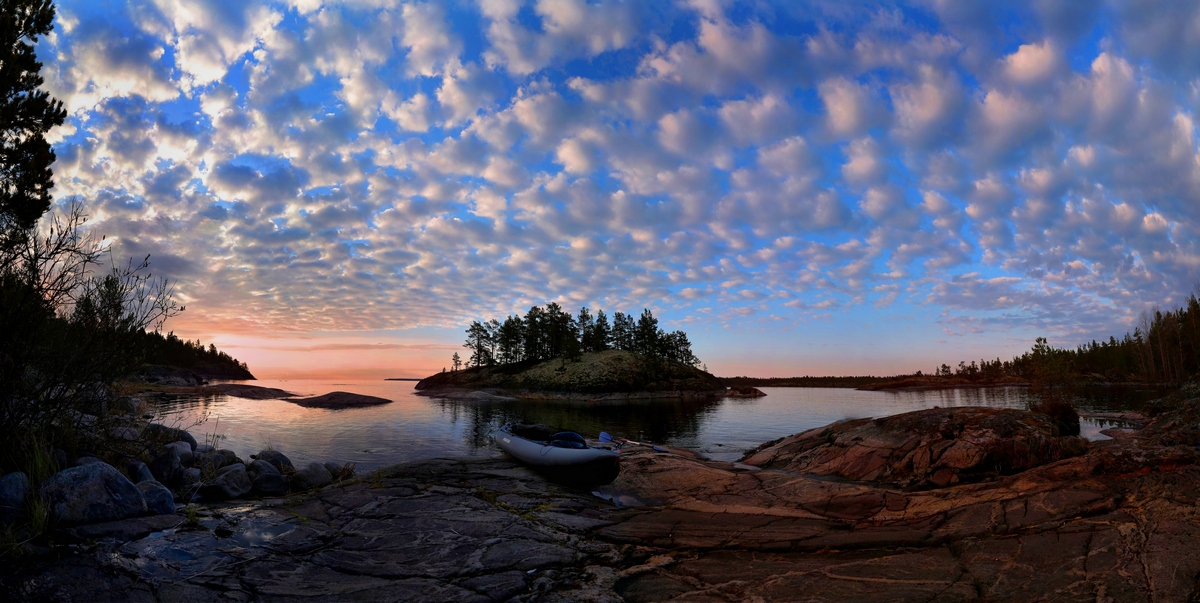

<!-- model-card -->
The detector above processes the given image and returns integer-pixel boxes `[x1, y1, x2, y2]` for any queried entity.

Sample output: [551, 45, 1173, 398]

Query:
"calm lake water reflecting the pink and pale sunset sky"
[145, 380, 1157, 470]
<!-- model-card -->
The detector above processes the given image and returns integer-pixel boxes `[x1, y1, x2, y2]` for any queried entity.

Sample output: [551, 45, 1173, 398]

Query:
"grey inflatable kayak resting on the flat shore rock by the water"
[492, 425, 620, 484]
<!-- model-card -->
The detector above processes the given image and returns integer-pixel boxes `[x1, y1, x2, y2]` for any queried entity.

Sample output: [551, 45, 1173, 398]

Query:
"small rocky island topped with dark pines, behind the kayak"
[416, 302, 725, 398]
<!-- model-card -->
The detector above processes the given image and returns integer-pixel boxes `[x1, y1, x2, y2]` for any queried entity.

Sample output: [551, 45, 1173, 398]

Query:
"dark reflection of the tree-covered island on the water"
[430, 398, 721, 449]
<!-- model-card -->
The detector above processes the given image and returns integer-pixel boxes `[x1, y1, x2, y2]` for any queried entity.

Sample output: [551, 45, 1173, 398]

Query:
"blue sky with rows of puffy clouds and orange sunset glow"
[37, 0, 1200, 378]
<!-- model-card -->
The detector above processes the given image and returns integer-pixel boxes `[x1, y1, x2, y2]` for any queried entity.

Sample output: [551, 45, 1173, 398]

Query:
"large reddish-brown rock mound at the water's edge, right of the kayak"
[742, 407, 1082, 488]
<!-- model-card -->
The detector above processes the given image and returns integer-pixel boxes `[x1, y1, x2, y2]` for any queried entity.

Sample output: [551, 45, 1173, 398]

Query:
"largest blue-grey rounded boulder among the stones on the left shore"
[37, 462, 146, 525]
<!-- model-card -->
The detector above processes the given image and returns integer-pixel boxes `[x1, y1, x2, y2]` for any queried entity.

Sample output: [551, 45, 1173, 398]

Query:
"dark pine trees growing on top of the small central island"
[452, 302, 700, 370]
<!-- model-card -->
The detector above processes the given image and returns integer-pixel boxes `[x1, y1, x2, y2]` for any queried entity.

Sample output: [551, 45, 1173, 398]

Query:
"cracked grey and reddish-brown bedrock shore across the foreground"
[7, 393, 1200, 602]
